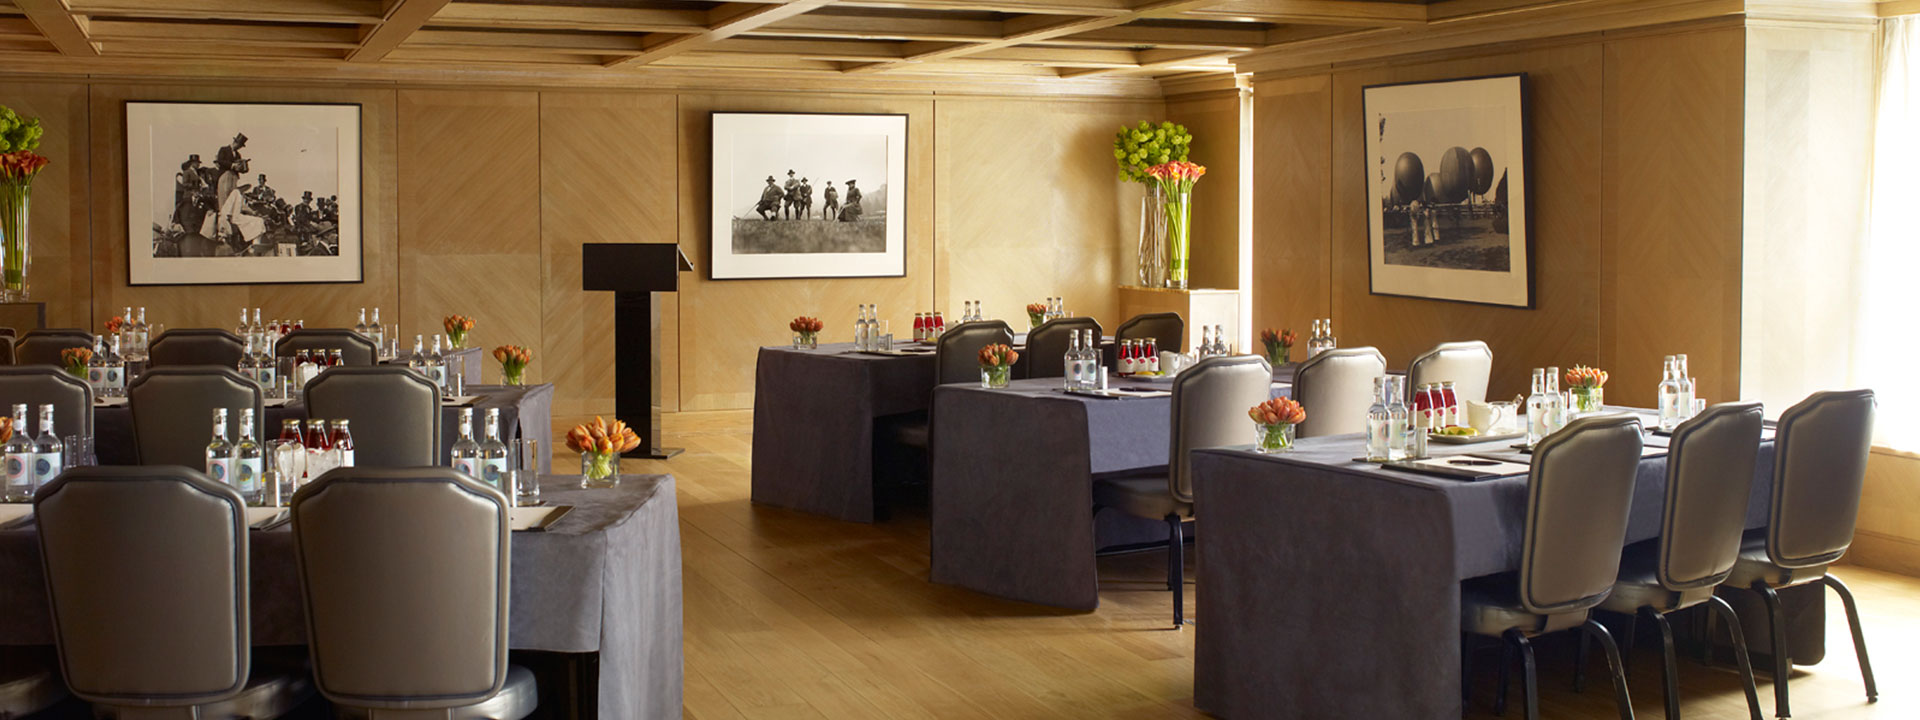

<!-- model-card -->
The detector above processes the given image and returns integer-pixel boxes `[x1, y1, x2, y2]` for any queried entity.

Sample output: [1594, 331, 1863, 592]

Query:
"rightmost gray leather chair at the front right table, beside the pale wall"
[1726, 390, 1880, 718]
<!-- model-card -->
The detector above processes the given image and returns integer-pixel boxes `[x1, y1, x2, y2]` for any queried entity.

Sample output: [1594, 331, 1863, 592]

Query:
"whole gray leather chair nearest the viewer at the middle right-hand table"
[1092, 355, 1273, 628]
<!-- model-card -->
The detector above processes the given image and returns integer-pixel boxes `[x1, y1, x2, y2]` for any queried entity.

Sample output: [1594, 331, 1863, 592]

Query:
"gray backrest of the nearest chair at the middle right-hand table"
[1167, 355, 1273, 503]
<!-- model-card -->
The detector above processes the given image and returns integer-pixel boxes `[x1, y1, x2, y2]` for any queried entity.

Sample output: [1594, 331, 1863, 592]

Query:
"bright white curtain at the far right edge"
[1851, 17, 1920, 451]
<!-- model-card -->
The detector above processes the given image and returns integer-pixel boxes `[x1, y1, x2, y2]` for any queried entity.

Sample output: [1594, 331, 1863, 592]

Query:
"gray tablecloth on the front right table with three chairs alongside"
[1192, 436, 1824, 718]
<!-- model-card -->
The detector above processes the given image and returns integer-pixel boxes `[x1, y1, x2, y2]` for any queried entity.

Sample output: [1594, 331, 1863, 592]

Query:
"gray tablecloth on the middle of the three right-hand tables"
[929, 378, 1290, 611]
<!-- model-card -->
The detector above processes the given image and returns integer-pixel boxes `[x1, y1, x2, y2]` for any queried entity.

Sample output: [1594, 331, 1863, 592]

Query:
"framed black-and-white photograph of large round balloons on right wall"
[1361, 75, 1534, 307]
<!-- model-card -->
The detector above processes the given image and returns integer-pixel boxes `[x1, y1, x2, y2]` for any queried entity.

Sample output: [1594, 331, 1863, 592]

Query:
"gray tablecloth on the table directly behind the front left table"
[94, 384, 553, 472]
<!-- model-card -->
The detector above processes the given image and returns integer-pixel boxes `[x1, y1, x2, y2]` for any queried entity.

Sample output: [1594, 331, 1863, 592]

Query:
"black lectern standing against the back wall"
[580, 242, 693, 459]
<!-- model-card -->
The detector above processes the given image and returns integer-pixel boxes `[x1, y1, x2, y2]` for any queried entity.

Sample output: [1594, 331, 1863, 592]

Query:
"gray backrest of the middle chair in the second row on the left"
[127, 365, 267, 467]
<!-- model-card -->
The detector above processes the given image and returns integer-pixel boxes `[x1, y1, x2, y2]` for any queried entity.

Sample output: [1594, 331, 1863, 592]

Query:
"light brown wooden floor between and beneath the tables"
[557, 411, 1920, 720]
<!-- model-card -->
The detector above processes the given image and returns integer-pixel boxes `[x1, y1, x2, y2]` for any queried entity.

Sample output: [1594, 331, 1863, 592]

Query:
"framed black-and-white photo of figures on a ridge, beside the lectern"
[710, 113, 906, 280]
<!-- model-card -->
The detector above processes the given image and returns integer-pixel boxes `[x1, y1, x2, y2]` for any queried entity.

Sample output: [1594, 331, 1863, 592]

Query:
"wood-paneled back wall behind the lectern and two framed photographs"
[0, 81, 1164, 415]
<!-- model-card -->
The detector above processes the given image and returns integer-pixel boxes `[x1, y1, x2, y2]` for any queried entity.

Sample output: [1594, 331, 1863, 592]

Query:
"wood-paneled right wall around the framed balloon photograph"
[1254, 27, 1743, 405]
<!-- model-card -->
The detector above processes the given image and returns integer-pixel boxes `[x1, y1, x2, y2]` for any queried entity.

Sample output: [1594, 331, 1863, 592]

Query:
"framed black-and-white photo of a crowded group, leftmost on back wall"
[127, 102, 361, 284]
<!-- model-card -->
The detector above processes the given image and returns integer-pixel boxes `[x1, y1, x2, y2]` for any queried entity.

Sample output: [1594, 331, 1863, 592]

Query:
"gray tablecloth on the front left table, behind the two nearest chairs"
[0, 474, 684, 718]
